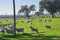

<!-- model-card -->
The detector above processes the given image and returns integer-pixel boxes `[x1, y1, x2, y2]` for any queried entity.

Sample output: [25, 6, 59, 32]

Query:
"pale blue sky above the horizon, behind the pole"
[0, 0, 40, 15]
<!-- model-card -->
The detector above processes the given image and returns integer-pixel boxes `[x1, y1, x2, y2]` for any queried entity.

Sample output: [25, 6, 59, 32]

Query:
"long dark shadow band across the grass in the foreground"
[1, 33, 60, 40]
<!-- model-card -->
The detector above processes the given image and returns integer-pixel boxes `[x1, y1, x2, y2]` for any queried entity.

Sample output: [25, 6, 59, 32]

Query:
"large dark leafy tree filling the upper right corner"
[39, 0, 60, 17]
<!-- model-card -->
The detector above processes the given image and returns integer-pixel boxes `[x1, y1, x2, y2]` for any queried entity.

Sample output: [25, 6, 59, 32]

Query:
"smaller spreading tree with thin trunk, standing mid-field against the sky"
[18, 5, 35, 20]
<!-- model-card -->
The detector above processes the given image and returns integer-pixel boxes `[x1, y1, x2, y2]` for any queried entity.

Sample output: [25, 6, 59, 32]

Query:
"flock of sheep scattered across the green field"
[0, 20, 51, 34]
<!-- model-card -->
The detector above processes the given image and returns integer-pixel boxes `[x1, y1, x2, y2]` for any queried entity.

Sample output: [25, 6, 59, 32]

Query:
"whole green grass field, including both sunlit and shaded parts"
[0, 18, 60, 40]
